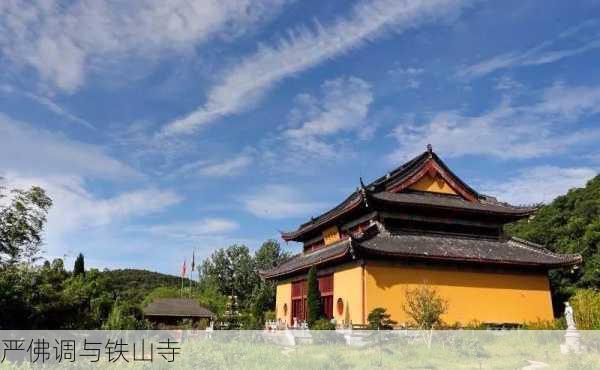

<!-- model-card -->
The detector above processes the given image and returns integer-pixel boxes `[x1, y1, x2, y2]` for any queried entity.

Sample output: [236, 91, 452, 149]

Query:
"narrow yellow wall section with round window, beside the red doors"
[333, 266, 364, 324]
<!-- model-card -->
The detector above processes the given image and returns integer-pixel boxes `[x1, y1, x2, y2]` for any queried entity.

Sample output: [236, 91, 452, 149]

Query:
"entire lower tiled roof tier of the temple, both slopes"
[263, 225, 582, 279]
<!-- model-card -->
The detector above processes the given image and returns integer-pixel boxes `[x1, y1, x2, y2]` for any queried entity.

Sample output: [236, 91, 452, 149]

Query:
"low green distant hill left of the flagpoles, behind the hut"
[95, 269, 196, 303]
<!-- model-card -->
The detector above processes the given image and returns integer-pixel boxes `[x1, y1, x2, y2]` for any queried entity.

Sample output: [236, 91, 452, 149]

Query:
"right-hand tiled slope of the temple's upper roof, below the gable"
[370, 191, 533, 216]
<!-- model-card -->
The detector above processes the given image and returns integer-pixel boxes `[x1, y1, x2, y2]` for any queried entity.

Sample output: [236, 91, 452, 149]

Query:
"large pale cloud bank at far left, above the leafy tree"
[0, 114, 181, 248]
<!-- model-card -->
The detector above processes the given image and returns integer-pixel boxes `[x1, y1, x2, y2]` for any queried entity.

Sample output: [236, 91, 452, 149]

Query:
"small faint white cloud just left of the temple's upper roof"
[241, 185, 326, 219]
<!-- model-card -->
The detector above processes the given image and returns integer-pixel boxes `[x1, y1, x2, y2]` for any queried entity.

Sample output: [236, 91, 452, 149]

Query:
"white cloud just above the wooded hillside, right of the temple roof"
[482, 166, 598, 205]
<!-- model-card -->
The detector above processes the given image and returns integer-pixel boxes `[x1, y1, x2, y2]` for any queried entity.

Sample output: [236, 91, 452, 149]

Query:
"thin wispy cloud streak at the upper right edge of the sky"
[457, 21, 600, 78]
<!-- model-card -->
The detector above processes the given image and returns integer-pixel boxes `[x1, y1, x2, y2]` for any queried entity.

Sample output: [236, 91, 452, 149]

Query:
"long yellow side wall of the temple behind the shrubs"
[365, 262, 553, 324]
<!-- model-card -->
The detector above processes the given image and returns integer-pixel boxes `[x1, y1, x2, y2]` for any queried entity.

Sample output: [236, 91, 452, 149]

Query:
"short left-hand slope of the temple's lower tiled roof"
[262, 239, 351, 278]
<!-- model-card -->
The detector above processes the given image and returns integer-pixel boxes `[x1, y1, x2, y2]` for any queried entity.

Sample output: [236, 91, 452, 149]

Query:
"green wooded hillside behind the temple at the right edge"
[507, 175, 600, 307]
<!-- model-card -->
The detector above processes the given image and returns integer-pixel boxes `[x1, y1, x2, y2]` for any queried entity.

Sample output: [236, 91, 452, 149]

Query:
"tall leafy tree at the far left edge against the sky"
[0, 183, 52, 266]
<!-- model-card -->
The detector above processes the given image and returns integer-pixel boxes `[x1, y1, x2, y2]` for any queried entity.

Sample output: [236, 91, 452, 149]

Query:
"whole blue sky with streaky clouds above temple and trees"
[0, 0, 600, 274]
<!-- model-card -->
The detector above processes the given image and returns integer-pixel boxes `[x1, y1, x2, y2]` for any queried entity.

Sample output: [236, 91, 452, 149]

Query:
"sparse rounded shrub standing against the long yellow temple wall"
[403, 286, 448, 329]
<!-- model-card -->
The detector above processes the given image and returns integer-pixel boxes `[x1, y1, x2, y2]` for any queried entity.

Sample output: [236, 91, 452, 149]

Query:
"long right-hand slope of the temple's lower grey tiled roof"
[357, 234, 581, 267]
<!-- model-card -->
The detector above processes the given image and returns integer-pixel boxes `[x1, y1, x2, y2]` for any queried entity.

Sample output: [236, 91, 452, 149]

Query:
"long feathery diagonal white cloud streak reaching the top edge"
[162, 0, 466, 135]
